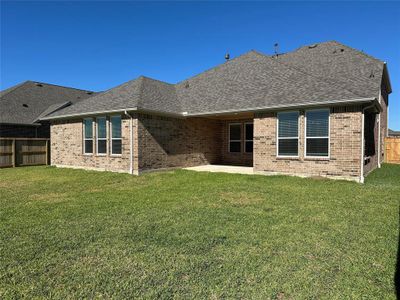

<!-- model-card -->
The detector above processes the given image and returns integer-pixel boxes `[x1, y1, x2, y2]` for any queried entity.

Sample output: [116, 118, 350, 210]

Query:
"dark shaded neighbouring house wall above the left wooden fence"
[0, 124, 50, 138]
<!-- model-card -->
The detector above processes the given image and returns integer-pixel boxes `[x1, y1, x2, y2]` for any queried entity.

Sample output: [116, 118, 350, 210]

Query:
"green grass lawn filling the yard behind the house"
[0, 165, 400, 299]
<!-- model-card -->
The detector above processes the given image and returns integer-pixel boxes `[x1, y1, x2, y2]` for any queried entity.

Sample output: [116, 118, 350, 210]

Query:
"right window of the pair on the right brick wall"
[305, 109, 329, 157]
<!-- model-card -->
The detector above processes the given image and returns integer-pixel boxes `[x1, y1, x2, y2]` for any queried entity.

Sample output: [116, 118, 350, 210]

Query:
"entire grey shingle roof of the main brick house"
[40, 41, 390, 119]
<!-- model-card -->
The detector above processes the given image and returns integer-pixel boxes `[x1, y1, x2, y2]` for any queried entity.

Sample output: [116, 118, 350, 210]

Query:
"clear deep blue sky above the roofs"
[0, 1, 400, 130]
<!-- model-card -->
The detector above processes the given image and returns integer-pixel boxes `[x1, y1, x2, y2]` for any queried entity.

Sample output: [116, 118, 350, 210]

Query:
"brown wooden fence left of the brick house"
[0, 138, 49, 168]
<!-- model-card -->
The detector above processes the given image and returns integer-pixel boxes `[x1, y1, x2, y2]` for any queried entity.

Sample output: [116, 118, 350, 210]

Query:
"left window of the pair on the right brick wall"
[277, 111, 299, 157]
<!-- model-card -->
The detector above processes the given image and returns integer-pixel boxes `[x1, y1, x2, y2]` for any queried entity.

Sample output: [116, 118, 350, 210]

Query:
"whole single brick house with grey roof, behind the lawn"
[43, 41, 391, 182]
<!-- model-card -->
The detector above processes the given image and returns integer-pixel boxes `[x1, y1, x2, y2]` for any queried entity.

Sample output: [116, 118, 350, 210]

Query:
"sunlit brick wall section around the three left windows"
[50, 116, 137, 172]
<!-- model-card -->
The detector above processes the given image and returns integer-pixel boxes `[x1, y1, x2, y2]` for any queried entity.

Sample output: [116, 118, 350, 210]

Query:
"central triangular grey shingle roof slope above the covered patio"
[176, 51, 361, 114]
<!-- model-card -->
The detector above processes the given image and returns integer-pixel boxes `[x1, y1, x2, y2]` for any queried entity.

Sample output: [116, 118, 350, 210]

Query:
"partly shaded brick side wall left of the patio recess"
[138, 114, 221, 171]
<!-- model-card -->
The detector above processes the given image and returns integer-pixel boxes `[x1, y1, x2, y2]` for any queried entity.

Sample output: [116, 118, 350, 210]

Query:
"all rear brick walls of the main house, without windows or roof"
[51, 106, 372, 180]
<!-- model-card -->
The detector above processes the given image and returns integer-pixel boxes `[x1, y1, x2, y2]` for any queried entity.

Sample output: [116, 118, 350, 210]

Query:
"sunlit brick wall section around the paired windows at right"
[254, 106, 362, 180]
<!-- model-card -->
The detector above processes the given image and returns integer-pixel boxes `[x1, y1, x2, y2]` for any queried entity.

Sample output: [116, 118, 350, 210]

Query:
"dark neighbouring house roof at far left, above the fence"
[0, 81, 95, 125]
